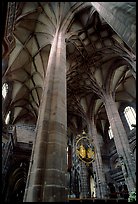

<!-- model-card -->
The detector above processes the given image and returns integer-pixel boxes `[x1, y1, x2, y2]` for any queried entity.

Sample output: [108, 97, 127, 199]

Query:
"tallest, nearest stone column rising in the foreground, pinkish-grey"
[24, 31, 67, 202]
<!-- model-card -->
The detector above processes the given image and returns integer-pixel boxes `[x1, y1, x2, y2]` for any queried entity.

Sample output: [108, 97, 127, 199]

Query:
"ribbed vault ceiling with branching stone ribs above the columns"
[4, 2, 135, 132]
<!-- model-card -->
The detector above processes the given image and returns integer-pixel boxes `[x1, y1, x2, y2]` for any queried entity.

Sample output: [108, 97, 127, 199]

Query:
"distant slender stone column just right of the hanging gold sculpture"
[89, 118, 107, 198]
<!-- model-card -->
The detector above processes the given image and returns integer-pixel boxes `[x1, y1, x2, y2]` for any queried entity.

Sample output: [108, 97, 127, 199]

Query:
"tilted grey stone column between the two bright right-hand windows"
[104, 94, 136, 192]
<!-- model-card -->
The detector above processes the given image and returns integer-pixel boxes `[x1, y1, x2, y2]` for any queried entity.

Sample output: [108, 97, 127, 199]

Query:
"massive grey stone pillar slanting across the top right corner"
[92, 2, 136, 53]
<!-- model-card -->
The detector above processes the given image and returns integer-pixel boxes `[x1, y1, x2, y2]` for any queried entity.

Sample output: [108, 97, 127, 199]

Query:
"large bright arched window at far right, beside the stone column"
[124, 106, 136, 130]
